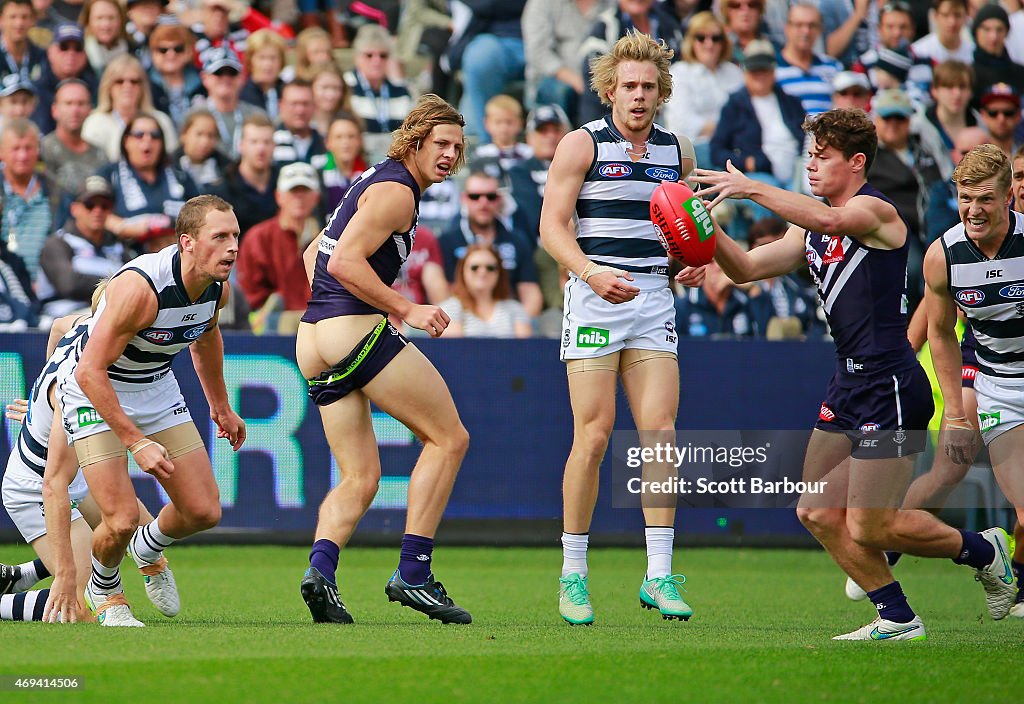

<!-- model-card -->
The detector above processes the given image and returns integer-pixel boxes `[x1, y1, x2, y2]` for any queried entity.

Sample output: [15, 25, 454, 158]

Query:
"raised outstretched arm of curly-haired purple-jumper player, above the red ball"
[690, 160, 906, 250]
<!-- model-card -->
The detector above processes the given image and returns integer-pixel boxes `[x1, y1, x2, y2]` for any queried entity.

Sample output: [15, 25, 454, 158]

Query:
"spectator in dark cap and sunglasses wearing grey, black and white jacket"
[37, 176, 131, 317]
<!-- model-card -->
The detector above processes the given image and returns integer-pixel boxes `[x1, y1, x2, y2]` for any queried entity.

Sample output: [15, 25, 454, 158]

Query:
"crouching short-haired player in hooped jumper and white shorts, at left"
[57, 195, 246, 626]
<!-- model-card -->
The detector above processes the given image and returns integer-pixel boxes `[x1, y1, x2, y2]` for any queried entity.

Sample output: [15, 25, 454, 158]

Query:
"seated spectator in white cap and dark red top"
[238, 162, 319, 334]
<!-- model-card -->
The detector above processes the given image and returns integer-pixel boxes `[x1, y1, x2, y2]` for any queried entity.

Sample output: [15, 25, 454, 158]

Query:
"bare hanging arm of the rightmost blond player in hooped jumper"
[925, 240, 978, 465]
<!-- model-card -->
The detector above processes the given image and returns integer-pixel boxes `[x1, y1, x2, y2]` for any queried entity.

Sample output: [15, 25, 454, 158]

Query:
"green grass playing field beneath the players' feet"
[0, 545, 1024, 704]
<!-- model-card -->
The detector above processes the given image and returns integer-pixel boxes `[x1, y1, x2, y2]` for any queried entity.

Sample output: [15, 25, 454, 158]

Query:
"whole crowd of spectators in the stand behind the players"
[6, 0, 1024, 339]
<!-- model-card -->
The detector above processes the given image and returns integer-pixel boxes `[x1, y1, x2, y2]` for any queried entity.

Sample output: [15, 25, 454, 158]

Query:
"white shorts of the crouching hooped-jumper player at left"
[57, 371, 191, 443]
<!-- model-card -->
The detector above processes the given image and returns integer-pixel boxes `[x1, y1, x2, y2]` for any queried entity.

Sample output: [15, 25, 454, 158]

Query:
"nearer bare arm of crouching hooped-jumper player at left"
[75, 270, 174, 479]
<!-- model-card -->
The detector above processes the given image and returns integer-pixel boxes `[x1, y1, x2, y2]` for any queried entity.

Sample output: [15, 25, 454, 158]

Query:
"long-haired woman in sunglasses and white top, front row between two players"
[441, 244, 531, 338]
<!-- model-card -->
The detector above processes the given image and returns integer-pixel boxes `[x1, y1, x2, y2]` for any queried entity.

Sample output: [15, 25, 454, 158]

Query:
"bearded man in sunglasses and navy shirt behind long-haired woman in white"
[438, 171, 543, 317]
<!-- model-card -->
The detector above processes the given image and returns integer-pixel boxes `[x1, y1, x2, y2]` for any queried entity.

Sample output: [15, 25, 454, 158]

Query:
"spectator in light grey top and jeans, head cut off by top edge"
[522, 0, 615, 120]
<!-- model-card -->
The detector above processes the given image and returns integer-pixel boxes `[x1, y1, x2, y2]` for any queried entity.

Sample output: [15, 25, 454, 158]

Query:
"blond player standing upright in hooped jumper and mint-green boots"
[541, 32, 693, 624]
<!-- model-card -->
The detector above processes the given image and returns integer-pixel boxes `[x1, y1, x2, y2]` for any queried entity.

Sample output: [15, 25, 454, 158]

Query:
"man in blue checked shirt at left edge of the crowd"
[0, 118, 59, 279]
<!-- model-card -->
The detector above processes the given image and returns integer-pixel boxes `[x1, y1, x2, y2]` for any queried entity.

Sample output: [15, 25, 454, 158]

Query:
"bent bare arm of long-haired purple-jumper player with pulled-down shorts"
[327, 182, 451, 338]
